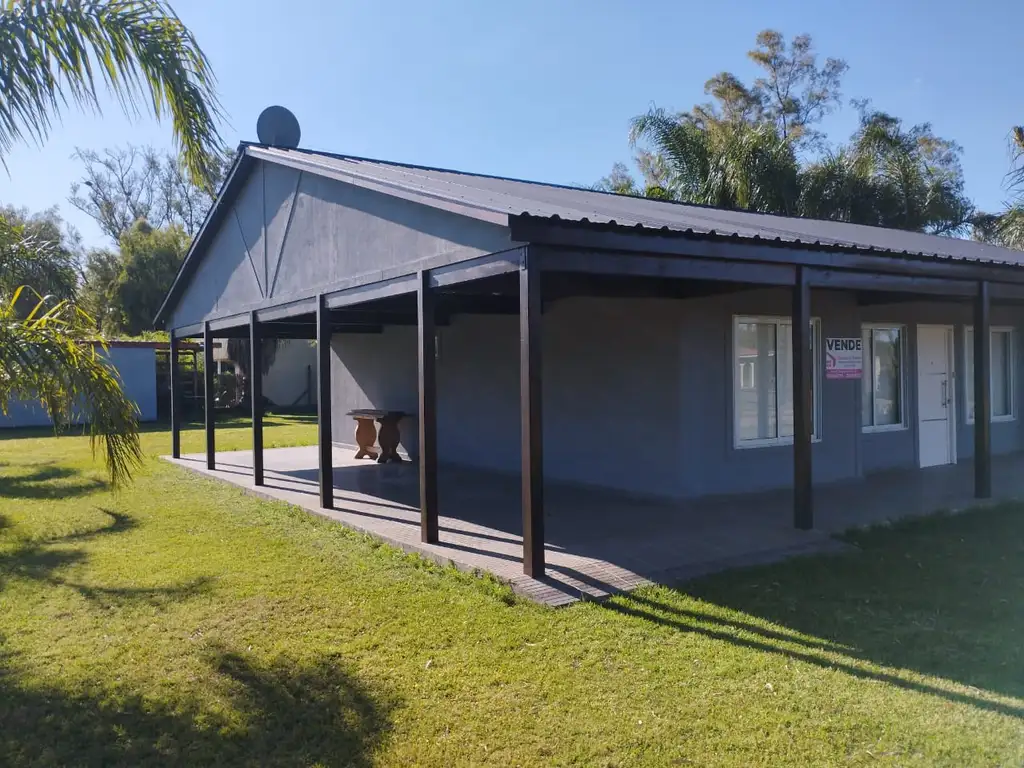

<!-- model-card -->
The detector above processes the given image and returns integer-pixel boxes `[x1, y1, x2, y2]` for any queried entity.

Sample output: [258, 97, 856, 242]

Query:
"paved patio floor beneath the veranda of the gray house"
[168, 445, 1024, 605]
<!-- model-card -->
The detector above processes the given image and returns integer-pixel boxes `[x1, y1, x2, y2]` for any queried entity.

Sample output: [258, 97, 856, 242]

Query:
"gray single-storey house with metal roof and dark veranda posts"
[151, 138, 1024, 574]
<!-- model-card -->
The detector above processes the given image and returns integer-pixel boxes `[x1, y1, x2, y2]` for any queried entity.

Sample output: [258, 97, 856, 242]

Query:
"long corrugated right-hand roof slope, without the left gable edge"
[246, 145, 1024, 266]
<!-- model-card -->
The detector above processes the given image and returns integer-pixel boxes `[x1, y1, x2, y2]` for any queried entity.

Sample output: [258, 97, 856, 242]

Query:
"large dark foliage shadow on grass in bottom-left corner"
[0, 645, 395, 768]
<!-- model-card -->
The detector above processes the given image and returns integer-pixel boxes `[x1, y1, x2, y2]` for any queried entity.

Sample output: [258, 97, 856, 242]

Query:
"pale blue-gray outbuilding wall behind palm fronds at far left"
[0, 339, 160, 429]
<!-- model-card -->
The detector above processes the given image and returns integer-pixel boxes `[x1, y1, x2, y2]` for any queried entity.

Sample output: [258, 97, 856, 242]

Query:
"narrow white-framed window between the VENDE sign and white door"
[860, 323, 907, 432]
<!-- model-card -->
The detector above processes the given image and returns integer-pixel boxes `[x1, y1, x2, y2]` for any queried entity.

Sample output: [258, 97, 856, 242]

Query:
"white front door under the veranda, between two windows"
[918, 326, 956, 467]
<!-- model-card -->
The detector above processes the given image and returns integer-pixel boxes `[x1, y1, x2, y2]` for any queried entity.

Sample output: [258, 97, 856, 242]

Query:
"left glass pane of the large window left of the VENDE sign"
[735, 323, 777, 440]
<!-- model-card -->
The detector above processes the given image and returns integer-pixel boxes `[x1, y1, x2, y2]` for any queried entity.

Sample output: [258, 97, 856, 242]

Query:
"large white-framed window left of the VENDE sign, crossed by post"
[732, 315, 821, 449]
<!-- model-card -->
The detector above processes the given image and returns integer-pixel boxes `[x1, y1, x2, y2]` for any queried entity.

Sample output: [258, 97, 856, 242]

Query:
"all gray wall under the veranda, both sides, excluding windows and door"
[332, 290, 1024, 498]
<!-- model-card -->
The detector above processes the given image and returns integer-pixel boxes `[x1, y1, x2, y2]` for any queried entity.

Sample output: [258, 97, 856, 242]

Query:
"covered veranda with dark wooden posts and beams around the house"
[163, 215, 1024, 592]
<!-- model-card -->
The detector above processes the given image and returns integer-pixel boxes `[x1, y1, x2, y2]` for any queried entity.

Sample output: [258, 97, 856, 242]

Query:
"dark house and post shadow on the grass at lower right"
[606, 504, 1024, 718]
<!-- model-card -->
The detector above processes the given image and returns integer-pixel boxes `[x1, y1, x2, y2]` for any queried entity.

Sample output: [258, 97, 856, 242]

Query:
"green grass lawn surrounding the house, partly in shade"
[0, 417, 1024, 766]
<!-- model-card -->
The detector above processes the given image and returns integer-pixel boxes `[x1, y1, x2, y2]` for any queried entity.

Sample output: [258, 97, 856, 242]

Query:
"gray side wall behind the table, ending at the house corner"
[332, 299, 684, 496]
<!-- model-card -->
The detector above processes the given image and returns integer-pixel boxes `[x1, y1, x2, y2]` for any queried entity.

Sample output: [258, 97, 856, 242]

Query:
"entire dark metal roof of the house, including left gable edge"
[154, 142, 1024, 327]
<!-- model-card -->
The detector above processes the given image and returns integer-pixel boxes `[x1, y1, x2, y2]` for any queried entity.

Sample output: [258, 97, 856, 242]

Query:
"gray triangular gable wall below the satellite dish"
[168, 162, 515, 328]
